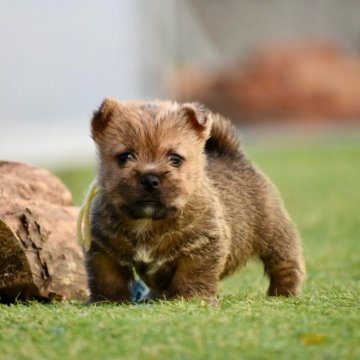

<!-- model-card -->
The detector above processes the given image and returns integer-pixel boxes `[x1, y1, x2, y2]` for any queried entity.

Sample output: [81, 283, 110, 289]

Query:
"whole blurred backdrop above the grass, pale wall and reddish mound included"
[0, 0, 360, 167]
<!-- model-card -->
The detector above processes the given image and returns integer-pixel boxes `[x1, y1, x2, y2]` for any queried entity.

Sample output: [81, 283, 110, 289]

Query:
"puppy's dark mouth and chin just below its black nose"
[126, 200, 168, 220]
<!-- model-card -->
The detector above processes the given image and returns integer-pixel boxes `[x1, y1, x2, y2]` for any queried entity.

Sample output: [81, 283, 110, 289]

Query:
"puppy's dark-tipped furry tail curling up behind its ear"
[205, 113, 243, 158]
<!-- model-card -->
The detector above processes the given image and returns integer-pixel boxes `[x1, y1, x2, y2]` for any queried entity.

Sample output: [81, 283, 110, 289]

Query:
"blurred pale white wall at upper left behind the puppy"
[0, 0, 143, 163]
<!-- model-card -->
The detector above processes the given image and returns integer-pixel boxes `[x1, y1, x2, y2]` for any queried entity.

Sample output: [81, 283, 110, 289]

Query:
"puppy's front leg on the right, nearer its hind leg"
[167, 255, 222, 305]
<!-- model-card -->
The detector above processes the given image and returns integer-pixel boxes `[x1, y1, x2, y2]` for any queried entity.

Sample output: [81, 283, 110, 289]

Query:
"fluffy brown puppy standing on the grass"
[86, 99, 304, 302]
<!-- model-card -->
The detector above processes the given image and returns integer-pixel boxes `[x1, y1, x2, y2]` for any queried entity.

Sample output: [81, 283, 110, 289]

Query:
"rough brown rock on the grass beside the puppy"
[0, 162, 87, 302]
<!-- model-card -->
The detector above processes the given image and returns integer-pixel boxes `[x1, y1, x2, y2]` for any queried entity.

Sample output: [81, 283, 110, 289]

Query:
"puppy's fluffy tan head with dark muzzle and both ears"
[91, 98, 211, 219]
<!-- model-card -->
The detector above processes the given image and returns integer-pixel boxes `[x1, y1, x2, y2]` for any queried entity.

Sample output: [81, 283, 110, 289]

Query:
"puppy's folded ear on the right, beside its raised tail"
[180, 102, 211, 140]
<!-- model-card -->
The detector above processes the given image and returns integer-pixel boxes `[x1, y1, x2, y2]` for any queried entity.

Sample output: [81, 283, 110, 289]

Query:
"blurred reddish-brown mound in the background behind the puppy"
[173, 42, 360, 122]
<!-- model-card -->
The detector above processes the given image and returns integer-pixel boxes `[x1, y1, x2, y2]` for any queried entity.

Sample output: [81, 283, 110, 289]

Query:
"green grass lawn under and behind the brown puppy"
[0, 137, 360, 360]
